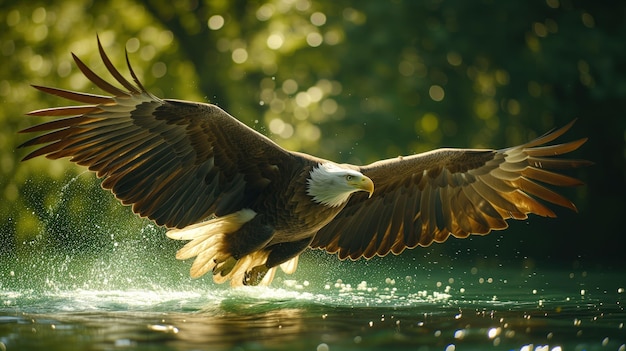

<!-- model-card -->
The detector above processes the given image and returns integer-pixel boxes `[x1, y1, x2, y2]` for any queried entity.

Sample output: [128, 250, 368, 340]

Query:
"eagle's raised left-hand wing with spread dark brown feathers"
[20, 40, 290, 228]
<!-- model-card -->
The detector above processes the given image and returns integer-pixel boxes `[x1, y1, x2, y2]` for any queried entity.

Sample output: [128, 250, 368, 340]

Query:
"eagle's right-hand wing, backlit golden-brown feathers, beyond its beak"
[311, 121, 590, 259]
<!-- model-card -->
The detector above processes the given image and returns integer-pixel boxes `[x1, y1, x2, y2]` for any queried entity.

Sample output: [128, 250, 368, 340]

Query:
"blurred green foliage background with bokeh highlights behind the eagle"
[0, 0, 626, 268]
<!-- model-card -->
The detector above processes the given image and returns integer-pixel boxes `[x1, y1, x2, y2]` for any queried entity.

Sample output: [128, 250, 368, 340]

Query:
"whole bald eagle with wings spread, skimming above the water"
[20, 39, 589, 285]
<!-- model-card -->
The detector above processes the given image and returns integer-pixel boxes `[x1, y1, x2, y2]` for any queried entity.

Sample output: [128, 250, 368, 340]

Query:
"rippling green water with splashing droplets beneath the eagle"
[0, 252, 626, 351]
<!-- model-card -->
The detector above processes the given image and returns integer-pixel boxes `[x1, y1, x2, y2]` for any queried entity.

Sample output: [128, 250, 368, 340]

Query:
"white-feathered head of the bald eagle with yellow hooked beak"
[307, 162, 374, 207]
